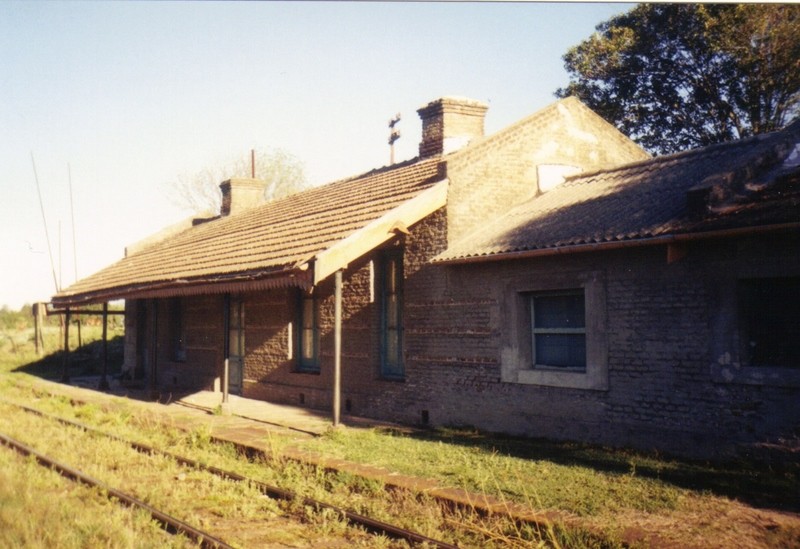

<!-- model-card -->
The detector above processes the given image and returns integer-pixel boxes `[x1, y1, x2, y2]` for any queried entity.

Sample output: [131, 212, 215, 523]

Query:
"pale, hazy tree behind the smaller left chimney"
[170, 149, 308, 214]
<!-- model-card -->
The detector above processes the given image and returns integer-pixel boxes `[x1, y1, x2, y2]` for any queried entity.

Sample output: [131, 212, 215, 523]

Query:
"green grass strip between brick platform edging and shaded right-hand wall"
[304, 429, 800, 516]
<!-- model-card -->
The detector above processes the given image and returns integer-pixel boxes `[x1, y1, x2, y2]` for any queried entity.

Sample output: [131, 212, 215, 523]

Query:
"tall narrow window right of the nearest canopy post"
[381, 251, 405, 379]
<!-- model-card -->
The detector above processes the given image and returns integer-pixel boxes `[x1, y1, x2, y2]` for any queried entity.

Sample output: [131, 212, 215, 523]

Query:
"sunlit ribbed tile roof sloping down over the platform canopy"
[53, 158, 443, 305]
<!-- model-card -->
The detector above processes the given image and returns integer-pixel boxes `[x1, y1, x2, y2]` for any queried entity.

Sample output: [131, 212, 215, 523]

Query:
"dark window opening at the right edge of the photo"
[737, 277, 800, 368]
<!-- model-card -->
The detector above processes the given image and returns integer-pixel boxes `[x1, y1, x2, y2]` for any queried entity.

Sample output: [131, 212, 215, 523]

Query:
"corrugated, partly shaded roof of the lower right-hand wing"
[435, 122, 800, 261]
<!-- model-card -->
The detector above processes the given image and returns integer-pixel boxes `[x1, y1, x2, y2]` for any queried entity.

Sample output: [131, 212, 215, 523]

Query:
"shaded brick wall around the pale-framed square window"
[372, 232, 800, 456]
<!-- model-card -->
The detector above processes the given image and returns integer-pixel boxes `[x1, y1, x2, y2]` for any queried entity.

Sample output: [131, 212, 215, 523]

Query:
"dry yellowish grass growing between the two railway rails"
[0, 398, 378, 547]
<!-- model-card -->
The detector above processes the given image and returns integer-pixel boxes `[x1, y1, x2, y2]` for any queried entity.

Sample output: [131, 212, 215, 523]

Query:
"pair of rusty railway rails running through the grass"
[0, 400, 456, 549]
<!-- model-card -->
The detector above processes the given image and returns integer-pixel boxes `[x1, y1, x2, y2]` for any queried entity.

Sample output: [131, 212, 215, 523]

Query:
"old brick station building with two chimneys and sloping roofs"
[53, 98, 800, 456]
